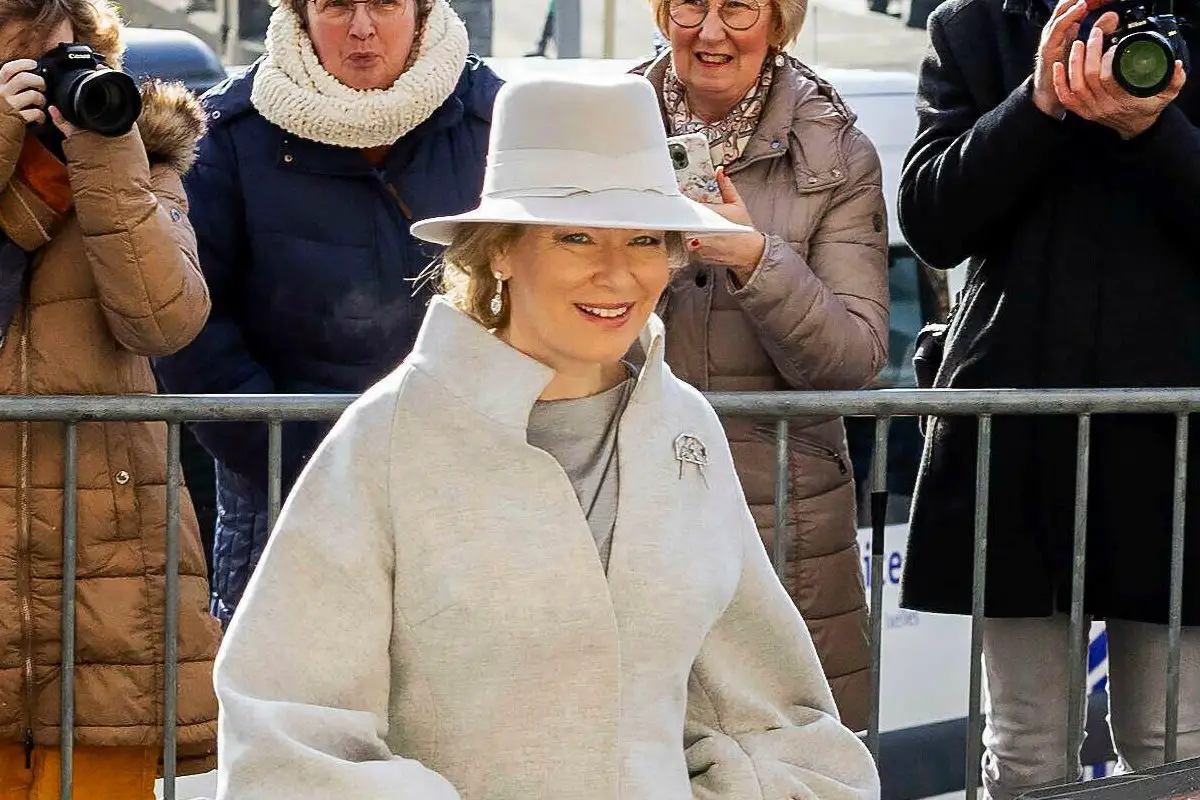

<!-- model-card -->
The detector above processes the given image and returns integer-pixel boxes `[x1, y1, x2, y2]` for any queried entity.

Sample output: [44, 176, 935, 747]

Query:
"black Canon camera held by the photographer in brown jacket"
[34, 42, 142, 136]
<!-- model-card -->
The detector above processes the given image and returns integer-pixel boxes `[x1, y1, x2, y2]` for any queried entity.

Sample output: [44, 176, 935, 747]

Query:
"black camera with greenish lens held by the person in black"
[1104, 0, 1189, 97]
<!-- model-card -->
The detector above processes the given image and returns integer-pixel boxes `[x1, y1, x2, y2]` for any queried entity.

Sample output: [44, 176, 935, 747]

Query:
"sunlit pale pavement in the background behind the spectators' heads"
[121, 0, 928, 72]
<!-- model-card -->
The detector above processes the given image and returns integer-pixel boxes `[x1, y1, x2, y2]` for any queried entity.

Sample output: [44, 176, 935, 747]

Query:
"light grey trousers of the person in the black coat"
[983, 614, 1200, 800]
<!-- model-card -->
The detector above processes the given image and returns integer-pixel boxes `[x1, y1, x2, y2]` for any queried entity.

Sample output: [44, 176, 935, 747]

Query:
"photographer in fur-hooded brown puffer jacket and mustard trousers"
[0, 0, 220, 800]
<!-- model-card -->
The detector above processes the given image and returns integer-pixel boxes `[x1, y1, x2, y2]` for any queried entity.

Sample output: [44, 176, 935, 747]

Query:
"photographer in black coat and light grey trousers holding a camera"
[899, 0, 1200, 800]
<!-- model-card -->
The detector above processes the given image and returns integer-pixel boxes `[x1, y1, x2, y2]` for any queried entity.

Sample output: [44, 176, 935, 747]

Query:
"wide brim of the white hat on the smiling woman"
[412, 190, 754, 245]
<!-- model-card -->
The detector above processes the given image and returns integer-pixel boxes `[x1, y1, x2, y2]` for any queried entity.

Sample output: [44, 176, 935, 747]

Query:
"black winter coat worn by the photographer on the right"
[899, 0, 1200, 625]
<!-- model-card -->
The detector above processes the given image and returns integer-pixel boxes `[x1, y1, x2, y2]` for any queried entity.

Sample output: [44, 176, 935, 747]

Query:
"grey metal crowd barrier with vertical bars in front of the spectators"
[7, 389, 1200, 800]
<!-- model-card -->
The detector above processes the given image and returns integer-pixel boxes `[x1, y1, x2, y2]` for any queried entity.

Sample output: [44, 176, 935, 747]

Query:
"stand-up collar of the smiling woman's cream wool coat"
[407, 296, 666, 438]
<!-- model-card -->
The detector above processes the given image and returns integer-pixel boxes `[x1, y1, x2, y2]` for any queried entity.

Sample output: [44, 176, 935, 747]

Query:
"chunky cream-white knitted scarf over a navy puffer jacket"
[250, 0, 468, 148]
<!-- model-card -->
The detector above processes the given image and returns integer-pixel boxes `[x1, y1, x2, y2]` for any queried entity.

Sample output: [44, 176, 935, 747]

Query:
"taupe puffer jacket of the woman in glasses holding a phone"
[640, 55, 888, 730]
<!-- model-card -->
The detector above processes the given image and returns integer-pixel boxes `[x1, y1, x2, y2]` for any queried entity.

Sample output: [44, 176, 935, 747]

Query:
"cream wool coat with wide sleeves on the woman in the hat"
[216, 300, 880, 800]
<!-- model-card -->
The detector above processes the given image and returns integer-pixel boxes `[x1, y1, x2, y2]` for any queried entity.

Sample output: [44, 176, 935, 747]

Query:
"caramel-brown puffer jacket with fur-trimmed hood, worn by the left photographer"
[0, 84, 220, 774]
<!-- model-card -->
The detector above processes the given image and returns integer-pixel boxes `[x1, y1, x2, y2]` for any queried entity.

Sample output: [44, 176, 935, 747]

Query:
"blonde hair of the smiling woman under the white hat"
[438, 222, 688, 329]
